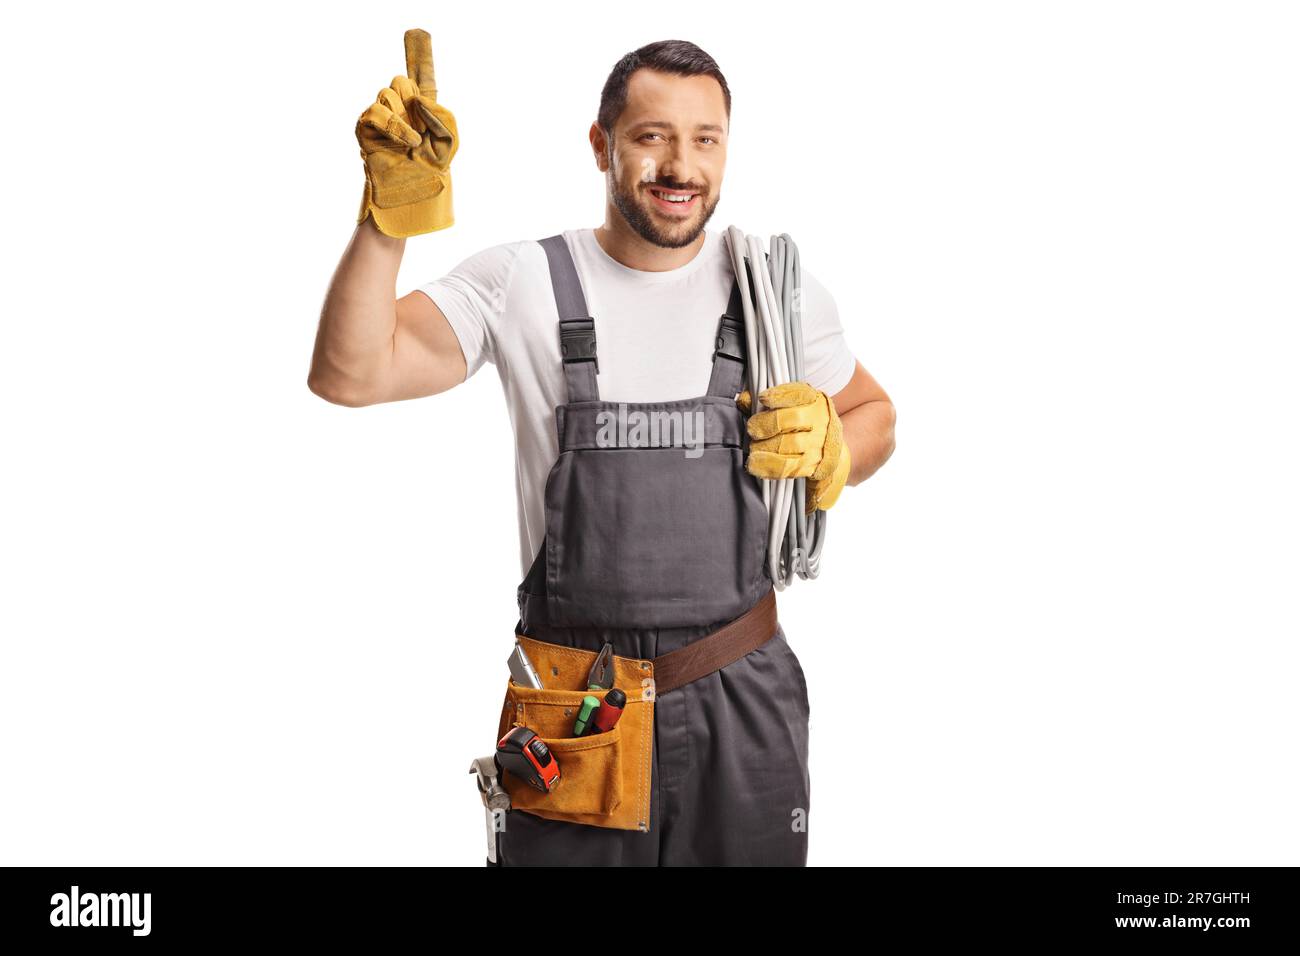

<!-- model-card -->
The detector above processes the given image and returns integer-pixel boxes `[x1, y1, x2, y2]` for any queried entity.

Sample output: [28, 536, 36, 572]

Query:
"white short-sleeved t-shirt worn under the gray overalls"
[420, 229, 855, 578]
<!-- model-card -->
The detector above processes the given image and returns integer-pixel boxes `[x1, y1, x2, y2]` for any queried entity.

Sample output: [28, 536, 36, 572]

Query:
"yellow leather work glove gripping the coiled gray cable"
[736, 381, 850, 514]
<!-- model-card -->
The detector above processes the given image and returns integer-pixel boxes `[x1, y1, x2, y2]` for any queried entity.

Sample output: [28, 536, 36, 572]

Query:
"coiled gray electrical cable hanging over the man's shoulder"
[725, 226, 826, 591]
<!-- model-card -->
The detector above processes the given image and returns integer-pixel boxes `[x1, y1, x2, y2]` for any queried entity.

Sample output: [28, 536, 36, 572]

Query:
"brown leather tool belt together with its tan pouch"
[497, 591, 776, 831]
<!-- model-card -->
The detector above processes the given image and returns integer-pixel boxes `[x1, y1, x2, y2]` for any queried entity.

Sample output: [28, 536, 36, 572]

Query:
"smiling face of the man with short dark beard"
[606, 69, 728, 248]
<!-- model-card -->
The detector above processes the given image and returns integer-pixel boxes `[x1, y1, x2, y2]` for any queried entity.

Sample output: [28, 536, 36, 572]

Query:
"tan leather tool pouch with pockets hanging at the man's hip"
[497, 635, 655, 831]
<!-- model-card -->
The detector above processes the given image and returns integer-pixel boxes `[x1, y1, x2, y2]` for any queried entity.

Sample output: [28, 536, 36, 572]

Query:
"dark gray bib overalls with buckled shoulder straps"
[498, 235, 809, 866]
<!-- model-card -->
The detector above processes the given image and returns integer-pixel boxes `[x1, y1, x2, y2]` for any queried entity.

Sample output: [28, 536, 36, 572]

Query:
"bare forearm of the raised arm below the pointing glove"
[307, 219, 406, 405]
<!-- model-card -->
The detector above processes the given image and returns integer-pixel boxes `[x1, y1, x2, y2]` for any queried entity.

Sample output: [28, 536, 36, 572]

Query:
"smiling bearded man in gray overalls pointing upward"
[308, 30, 894, 865]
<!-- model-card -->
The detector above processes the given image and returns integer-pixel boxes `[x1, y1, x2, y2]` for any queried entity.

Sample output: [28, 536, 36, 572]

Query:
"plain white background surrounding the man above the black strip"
[0, 1, 1300, 865]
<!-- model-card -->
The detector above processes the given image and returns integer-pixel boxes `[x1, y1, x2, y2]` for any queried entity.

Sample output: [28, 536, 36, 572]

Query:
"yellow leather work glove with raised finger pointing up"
[356, 30, 460, 239]
